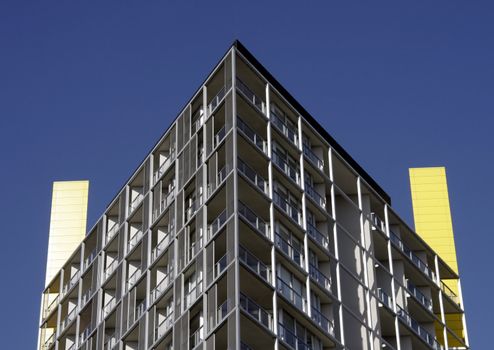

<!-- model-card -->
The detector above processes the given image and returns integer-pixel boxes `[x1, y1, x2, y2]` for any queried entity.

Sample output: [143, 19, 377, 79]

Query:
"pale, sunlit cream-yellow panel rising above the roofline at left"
[45, 181, 89, 284]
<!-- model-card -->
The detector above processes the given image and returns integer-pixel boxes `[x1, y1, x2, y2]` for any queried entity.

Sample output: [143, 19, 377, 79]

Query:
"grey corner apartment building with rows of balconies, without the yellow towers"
[39, 41, 468, 350]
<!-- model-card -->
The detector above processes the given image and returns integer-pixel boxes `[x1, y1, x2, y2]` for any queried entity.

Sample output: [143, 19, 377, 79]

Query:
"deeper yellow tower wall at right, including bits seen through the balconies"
[409, 167, 463, 346]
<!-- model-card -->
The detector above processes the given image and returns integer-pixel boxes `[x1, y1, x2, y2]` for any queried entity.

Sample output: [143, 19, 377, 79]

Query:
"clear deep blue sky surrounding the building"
[0, 0, 494, 349]
